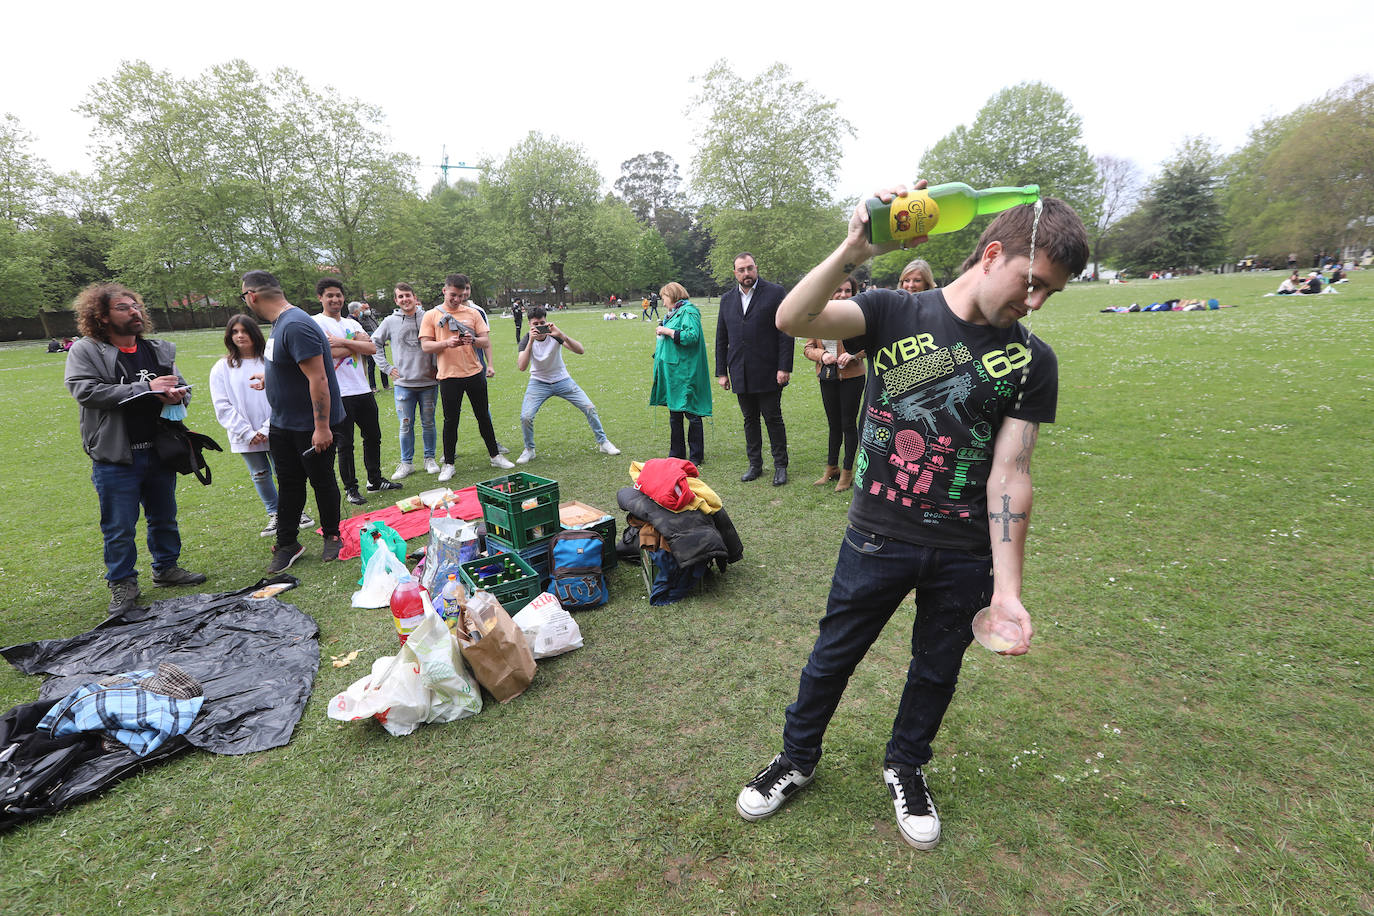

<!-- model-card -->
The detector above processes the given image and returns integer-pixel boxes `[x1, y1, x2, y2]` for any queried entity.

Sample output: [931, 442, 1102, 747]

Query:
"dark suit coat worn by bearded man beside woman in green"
[716, 279, 796, 394]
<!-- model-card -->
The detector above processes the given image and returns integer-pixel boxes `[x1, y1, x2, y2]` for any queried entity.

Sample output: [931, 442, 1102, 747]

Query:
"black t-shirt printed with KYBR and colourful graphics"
[845, 290, 1059, 552]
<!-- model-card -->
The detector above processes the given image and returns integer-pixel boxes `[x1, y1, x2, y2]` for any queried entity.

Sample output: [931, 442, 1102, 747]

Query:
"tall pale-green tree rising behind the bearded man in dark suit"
[692, 60, 853, 283]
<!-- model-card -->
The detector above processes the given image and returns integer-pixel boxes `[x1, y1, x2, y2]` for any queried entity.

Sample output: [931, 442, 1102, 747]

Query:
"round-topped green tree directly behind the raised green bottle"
[919, 82, 1098, 282]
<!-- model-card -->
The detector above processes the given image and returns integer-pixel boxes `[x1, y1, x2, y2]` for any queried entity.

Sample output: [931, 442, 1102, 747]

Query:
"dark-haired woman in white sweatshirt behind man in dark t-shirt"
[210, 314, 315, 537]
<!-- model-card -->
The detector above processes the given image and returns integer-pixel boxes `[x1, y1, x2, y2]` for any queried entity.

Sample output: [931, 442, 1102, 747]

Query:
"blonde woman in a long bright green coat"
[649, 283, 710, 464]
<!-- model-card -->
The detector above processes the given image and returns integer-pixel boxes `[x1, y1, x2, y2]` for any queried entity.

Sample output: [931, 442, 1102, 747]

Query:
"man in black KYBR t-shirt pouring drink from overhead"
[735, 183, 1088, 849]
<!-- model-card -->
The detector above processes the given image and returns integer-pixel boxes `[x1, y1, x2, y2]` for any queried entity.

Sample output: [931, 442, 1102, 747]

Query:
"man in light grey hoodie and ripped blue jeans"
[372, 283, 438, 481]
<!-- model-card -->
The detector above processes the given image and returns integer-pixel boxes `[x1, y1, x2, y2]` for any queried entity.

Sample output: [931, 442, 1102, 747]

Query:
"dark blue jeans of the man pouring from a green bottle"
[782, 527, 992, 772]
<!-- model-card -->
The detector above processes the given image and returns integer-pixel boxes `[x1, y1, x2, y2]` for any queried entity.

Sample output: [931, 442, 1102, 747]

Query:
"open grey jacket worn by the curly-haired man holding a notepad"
[63, 336, 191, 464]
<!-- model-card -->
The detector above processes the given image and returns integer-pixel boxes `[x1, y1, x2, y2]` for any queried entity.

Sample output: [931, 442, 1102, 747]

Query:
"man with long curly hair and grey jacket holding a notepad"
[65, 283, 205, 615]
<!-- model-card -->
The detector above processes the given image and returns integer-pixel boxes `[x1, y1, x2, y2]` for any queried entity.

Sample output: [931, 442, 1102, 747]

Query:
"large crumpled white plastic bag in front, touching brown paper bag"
[328, 602, 482, 735]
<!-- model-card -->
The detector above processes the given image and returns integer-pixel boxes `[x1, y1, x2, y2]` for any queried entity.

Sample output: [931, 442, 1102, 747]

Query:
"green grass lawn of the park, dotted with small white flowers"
[0, 272, 1374, 915]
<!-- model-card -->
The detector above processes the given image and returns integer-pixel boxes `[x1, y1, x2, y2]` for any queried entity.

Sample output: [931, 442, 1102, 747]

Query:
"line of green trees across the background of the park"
[0, 60, 1374, 328]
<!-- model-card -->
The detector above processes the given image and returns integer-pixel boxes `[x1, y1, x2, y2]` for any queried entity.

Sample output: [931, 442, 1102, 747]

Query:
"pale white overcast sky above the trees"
[0, 0, 1374, 204]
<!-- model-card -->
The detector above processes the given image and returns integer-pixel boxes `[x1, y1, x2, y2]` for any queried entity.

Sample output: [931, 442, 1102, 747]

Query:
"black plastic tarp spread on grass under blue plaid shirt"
[0, 575, 320, 829]
